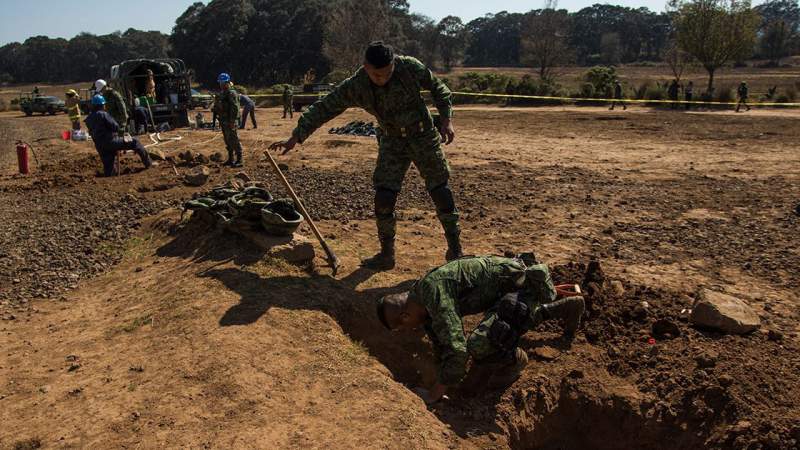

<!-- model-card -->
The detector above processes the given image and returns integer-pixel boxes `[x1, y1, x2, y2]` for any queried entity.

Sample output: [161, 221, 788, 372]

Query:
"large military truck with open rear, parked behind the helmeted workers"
[101, 59, 192, 128]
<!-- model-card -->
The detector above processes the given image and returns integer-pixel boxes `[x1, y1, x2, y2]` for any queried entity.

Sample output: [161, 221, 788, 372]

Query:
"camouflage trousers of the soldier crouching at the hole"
[467, 264, 556, 363]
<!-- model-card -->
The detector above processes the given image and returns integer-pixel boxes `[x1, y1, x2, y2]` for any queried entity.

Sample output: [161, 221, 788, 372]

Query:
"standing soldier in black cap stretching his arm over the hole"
[270, 42, 462, 270]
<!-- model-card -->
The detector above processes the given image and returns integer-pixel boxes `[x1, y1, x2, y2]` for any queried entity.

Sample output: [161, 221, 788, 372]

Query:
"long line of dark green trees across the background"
[0, 0, 800, 86]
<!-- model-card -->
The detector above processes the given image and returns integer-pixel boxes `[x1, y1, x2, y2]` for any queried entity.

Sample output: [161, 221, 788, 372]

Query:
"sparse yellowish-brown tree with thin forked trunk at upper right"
[674, 0, 761, 92]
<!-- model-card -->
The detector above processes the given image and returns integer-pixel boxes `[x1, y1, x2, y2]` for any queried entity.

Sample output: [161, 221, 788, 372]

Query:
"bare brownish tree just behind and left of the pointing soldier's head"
[322, 0, 392, 71]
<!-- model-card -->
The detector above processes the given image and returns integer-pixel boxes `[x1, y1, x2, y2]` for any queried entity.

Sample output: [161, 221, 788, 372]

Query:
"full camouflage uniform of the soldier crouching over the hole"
[410, 256, 556, 386]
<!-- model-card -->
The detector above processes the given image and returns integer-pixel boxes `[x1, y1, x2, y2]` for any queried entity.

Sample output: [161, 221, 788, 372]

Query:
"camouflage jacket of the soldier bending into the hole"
[412, 256, 536, 386]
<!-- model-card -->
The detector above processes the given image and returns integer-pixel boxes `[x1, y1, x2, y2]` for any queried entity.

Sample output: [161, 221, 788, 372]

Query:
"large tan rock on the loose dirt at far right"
[690, 289, 761, 334]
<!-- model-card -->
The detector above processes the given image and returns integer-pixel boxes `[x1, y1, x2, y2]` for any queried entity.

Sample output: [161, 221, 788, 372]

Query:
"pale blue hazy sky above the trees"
[0, 0, 680, 45]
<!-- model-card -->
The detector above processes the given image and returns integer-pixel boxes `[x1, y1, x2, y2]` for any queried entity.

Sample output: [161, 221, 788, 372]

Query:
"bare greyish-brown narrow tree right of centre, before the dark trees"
[521, 0, 571, 82]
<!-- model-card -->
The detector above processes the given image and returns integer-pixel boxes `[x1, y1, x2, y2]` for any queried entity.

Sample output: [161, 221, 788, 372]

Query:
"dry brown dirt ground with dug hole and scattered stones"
[0, 103, 800, 449]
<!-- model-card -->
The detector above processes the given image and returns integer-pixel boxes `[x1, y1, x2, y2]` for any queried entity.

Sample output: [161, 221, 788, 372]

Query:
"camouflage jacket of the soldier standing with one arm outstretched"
[292, 56, 453, 142]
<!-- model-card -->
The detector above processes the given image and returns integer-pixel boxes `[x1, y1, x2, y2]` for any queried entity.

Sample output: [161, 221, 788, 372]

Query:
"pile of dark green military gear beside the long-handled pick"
[183, 180, 303, 236]
